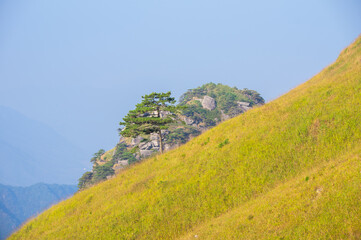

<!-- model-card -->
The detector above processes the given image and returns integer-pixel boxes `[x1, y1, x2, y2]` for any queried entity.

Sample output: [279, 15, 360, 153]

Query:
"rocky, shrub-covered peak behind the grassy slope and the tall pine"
[78, 83, 264, 189]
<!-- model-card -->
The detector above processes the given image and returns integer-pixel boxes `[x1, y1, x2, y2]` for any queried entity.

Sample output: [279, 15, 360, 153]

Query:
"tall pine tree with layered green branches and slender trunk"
[119, 92, 179, 153]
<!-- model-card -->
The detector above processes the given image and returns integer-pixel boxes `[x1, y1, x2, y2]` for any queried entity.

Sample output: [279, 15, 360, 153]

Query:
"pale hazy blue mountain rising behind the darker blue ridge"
[0, 106, 89, 186]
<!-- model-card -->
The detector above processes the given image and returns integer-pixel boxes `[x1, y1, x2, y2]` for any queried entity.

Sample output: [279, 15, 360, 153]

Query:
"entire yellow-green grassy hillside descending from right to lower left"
[11, 38, 361, 239]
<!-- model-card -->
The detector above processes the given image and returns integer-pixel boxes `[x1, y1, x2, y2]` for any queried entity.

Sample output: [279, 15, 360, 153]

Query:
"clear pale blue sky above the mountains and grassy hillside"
[0, 0, 361, 156]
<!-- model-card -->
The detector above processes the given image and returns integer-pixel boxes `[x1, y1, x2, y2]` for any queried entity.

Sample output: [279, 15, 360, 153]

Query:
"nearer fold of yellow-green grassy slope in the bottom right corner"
[182, 149, 361, 239]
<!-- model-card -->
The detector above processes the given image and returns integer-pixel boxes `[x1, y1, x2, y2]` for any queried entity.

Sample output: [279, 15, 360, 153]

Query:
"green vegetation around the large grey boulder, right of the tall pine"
[165, 83, 264, 148]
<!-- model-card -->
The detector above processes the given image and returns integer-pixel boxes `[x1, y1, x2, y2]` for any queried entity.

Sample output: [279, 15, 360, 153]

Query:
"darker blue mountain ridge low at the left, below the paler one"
[0, 183, 77, 239]
